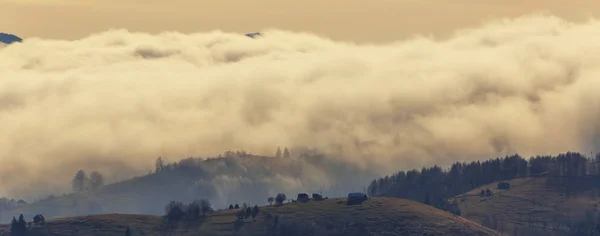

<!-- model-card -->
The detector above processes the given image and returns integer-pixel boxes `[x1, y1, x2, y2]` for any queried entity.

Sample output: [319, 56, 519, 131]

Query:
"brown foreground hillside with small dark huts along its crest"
[0, 197, 499, 236]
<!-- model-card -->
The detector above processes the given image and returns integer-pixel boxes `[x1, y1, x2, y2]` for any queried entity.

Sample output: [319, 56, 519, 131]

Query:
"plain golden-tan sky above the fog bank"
[0, 0, 600, 43]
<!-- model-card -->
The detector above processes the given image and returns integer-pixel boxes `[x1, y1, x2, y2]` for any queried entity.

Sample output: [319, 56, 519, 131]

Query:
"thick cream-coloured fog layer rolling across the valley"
[0, 16, 600, 196]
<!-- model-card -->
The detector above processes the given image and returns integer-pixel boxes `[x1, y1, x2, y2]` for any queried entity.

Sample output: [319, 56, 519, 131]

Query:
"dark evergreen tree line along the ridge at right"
[367, 152, 600, 209]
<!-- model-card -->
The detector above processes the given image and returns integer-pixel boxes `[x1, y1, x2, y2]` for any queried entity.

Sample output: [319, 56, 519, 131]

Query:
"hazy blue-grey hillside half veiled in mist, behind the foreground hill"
[0, 156, 376, 222]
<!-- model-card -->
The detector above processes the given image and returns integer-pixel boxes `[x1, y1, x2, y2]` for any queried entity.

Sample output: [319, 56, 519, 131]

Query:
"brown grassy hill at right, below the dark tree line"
[450, 177, 598, 236]
